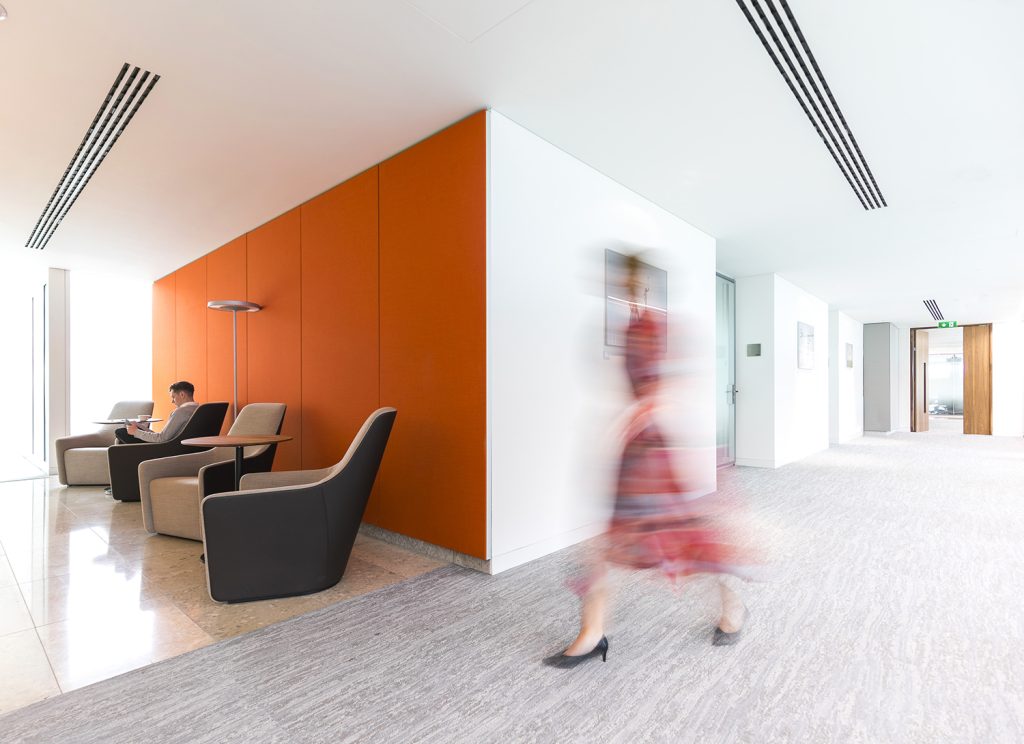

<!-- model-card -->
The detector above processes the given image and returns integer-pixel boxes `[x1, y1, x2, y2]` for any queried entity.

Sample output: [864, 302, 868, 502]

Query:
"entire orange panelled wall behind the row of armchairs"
[154, 112, 487, 558]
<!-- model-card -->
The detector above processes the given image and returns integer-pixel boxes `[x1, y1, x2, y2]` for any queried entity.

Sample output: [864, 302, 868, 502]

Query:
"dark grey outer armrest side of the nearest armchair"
[202, 485, 327, 602]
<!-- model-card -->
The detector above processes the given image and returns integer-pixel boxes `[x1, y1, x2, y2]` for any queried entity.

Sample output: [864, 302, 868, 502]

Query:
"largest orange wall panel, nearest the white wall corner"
[375, 112, 487, 558]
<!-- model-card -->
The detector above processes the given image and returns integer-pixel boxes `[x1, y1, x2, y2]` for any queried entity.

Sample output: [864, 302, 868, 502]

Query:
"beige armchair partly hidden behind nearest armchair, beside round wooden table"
[138, 403, 286, 540]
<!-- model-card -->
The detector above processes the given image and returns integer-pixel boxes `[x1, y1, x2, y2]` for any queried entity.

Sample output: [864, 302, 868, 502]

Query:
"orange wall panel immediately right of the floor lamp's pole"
[246, 209, 302, 470]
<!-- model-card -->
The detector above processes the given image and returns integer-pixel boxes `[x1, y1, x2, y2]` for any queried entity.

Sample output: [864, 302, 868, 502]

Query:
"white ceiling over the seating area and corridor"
[0, 0, 1024, 324]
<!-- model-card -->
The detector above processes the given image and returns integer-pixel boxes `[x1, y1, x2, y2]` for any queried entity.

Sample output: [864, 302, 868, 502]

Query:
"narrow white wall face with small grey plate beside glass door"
[736, 274, 775, 468]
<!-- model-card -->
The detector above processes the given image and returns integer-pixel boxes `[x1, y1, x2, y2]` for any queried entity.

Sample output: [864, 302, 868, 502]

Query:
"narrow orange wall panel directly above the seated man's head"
[173, 257, 210, 402]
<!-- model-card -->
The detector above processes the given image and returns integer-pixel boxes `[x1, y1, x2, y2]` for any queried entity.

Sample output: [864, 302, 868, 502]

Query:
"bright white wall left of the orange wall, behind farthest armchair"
[69, 271, 153, 433]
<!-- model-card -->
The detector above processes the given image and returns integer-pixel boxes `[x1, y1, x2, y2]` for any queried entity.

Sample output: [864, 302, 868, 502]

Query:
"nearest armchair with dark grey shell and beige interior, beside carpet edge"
[202, 408, 396, 602]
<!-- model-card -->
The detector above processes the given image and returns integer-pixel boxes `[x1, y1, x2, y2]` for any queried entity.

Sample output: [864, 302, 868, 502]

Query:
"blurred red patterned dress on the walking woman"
[606, 310, 738, 579]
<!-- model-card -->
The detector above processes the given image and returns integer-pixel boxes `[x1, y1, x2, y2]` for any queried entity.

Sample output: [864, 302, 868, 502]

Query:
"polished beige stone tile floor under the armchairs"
[0, 478, 444, 713]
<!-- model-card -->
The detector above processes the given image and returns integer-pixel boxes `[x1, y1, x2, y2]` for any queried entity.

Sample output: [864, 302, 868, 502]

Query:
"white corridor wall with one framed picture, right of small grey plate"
[773, 274, 828, 468]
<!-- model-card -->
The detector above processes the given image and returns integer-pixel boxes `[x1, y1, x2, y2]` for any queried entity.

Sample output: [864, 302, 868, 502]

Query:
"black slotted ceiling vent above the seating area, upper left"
[25, 62, 160, 250]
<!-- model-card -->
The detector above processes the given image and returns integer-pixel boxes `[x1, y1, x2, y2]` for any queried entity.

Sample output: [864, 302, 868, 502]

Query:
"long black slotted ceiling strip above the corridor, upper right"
[736, 0, 889, 210]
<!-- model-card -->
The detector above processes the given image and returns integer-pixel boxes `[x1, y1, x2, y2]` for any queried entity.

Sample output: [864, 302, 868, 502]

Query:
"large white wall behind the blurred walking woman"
[487, 112, 715, 572]
